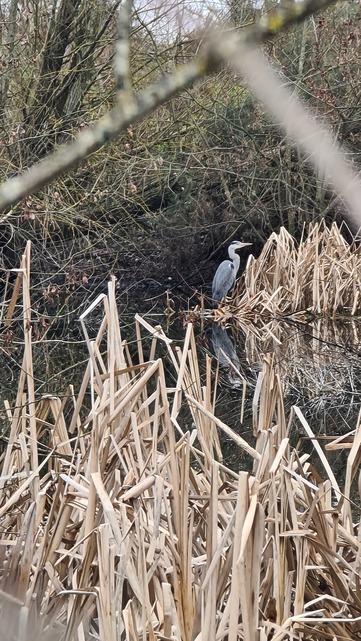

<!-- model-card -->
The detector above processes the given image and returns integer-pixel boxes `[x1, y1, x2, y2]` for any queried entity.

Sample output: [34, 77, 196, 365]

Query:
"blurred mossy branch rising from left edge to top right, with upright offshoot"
[0, 0, 351, 218]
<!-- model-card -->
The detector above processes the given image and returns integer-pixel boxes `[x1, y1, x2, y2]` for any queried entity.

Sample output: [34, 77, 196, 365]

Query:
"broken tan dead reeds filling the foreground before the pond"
[0, 246, 361, 641]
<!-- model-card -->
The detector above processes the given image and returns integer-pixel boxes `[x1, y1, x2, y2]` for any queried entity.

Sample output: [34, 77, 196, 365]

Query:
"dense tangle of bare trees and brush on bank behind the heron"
[0, 0, 361, 331]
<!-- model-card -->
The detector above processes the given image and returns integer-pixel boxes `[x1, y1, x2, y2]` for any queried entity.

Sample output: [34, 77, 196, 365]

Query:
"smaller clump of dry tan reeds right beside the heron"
[232, 222, 361, 325]
